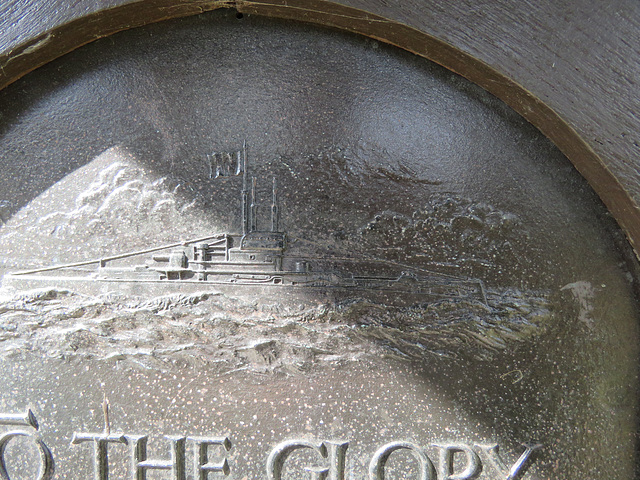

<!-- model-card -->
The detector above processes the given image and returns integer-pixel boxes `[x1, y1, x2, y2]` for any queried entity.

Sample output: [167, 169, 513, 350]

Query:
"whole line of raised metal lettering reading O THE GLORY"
[17, 410, 542, 480]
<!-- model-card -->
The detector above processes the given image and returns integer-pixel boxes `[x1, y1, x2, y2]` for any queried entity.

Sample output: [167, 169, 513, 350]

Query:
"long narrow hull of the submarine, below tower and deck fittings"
[2, 269, 486, 307]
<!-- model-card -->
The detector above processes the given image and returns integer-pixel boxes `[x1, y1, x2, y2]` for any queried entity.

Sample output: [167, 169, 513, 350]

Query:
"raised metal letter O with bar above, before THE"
[0, 410, 55, 480]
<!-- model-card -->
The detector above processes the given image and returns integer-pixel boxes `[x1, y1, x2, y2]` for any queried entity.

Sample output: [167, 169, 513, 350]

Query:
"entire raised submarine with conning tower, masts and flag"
[3, 143, 487, 306]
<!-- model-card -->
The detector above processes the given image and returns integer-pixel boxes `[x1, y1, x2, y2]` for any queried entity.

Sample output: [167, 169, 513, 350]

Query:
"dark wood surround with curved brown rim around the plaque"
[0, 0, 640, 252]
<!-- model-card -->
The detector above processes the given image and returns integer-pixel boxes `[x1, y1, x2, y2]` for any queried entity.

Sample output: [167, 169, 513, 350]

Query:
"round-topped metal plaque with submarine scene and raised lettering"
[0, 11, 638, 480]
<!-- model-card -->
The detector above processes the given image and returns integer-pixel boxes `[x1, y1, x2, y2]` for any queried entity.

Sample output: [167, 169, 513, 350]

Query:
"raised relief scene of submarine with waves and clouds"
[0, 144, 551, 370]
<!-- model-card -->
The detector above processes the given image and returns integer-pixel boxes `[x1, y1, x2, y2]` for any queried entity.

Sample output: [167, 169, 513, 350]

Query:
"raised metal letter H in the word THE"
[126, 435, 187, 480]
